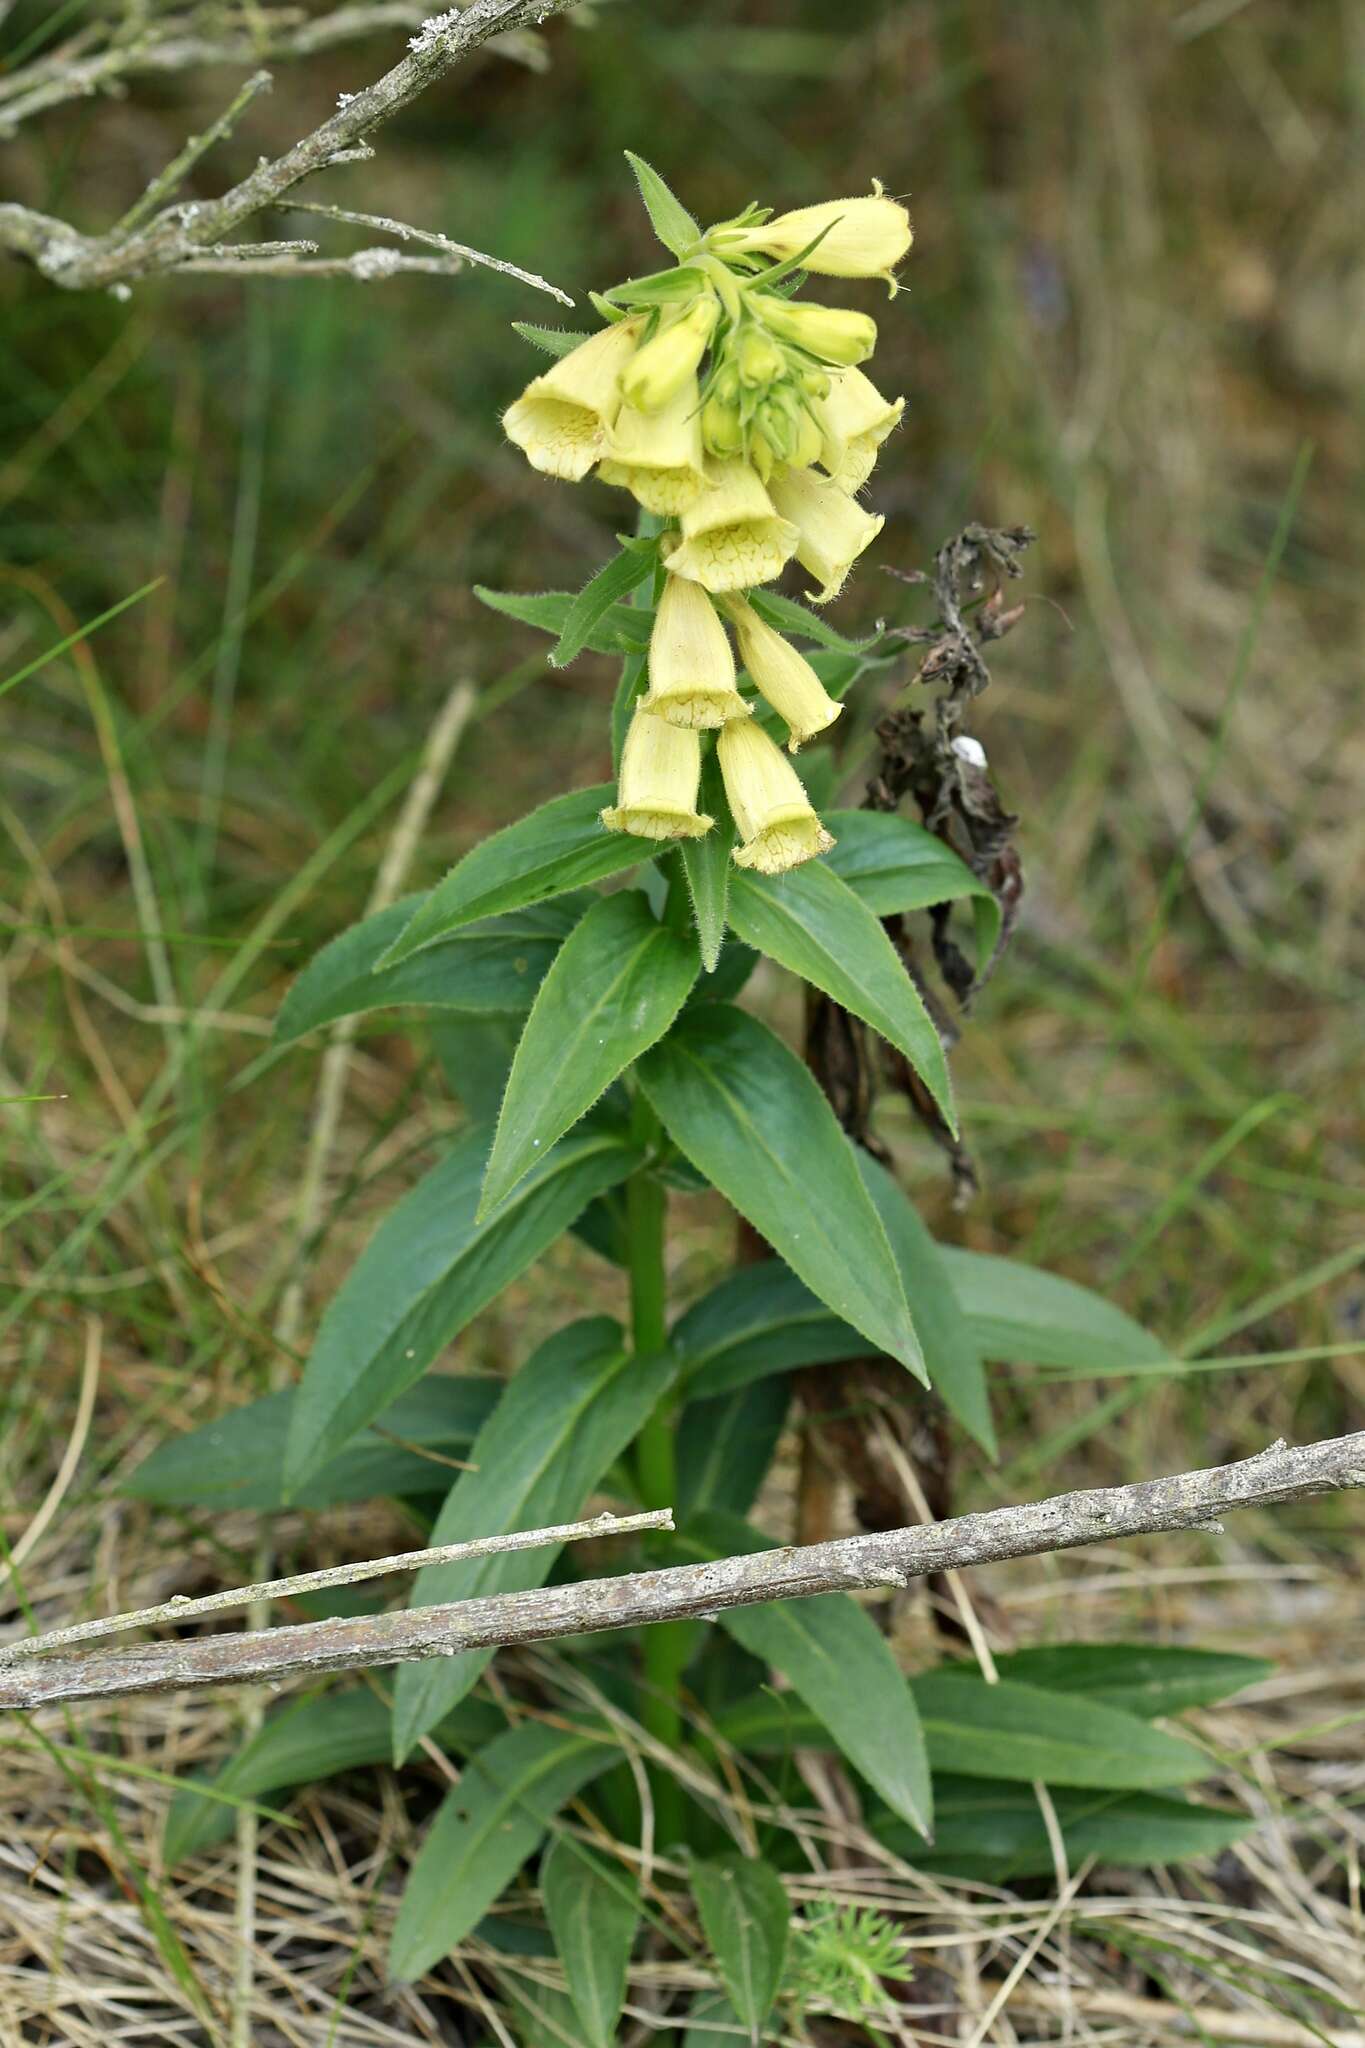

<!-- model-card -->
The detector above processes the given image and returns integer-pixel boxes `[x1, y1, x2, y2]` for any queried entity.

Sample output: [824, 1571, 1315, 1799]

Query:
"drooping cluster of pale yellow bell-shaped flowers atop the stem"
[503, 186, 911, 874]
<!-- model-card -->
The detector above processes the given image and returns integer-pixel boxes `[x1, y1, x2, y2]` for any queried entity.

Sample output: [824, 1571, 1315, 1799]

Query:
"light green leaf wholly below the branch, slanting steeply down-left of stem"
[389, 1720, 620, 1982]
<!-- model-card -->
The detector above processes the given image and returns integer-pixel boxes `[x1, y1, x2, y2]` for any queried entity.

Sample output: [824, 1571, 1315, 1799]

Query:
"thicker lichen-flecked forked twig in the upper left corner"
[0, 0, 579, 292]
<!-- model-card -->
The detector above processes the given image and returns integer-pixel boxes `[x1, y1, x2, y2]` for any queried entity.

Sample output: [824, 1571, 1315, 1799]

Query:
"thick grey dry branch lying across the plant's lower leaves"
[0, 1432, 1365, 1710]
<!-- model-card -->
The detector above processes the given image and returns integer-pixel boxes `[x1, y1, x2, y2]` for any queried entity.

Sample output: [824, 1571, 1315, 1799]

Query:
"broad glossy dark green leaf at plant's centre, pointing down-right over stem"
[639, 1004, 925, 1378]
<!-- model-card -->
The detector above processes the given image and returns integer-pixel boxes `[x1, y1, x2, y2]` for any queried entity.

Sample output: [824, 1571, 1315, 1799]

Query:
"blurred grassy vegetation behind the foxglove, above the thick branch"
[0, 0, 1365, 2031]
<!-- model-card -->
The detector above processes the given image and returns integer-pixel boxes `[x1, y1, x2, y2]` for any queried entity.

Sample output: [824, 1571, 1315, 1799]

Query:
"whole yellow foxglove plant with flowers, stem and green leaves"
[263, 164, 1219, 2042]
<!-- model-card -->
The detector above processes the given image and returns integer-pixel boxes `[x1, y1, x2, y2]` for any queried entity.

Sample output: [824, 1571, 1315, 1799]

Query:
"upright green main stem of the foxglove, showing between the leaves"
[626, 1096, 692, 1845]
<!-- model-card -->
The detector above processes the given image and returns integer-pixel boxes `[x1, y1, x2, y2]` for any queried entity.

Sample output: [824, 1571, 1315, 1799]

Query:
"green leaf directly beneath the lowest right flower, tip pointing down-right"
[729, 860, 956, 1128]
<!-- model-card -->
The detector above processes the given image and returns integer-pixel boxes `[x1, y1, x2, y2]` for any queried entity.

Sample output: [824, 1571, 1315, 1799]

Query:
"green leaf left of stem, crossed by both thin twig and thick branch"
[393, 1317, 677, 1759]
